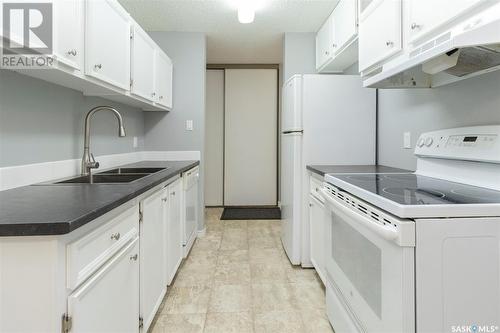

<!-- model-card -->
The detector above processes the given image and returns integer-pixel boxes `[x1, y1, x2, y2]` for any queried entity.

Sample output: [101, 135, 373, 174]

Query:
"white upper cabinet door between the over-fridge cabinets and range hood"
[359, 0, 402, 71]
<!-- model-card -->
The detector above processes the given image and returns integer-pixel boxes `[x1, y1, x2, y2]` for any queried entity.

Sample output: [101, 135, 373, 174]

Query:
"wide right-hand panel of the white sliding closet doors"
[224, 69, 278, 206]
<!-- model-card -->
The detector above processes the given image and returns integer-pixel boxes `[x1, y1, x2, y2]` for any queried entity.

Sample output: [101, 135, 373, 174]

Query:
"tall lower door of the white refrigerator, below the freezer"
[281, 133, 302, 265]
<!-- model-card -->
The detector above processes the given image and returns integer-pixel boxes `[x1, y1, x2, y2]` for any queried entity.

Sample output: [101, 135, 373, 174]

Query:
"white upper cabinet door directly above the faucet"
[85, 0, 130, 90]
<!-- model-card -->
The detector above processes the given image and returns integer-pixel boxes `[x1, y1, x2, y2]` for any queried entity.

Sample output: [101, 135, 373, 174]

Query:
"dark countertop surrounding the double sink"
[0, 161, 199, 236]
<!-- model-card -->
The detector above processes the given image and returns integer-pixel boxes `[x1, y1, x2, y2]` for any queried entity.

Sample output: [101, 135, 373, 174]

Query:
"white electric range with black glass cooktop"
[322, 126, 500, 333]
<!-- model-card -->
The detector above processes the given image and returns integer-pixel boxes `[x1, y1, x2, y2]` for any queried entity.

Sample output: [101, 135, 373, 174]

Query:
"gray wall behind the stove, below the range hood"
[379, 72, 500, 170]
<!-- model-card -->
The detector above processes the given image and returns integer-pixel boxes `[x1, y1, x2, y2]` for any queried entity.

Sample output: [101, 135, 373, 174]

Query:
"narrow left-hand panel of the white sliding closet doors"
[205, 70, 224, 206]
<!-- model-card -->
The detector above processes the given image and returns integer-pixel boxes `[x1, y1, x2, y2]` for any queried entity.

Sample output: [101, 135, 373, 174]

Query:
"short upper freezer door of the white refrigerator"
[281, 75, 302, 132]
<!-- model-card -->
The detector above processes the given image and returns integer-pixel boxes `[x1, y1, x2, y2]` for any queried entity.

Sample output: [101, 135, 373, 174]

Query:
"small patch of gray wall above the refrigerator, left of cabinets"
[283, 32, 316, 82]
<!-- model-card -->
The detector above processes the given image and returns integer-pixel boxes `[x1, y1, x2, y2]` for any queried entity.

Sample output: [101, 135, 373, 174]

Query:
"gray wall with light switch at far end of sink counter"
[144, 32, 206, 230]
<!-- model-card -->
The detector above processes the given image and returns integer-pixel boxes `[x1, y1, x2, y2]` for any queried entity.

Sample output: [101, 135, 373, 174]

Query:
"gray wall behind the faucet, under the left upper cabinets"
[0, 70, 144, 167]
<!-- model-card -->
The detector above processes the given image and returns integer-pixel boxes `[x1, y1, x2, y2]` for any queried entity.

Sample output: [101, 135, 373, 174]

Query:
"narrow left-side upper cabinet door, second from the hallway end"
[130, 24, 157, 101]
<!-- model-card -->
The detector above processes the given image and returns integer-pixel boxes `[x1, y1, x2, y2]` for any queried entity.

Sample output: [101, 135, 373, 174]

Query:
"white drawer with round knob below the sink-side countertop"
[66, 205, 139, 289]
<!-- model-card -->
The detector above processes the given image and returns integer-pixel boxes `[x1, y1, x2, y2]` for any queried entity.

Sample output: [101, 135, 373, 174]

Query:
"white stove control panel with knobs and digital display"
[415, 125, 500, 163]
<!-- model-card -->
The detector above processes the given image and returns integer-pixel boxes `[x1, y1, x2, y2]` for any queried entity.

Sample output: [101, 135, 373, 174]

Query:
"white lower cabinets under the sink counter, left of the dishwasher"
[0, 172, 197, 333]
